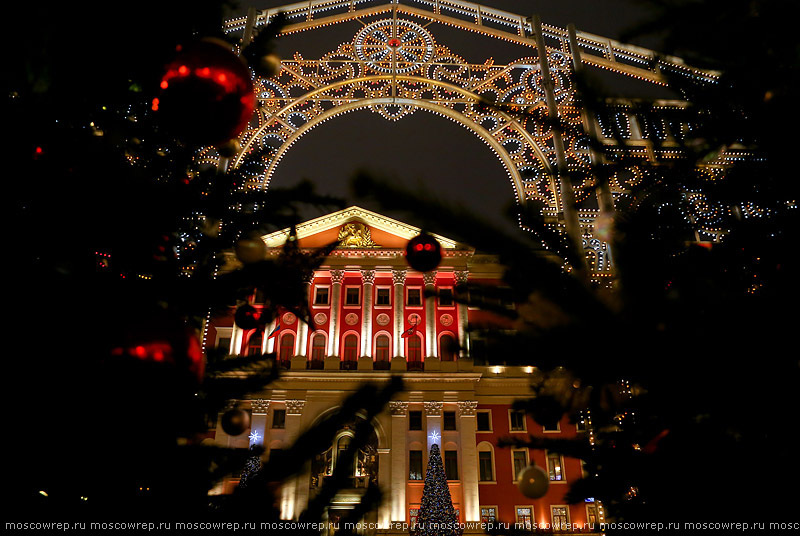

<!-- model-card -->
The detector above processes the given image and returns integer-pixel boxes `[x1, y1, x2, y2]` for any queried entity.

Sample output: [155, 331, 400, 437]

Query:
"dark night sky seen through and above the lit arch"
[230, 0, 664, 234]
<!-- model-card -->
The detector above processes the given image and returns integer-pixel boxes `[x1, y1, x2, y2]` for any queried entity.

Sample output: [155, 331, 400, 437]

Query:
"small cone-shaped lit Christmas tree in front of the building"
[411, 443, 462, 536]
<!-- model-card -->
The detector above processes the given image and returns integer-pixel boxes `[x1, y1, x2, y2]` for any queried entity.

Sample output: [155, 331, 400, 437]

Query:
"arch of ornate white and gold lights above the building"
[206, 0, 718, 251]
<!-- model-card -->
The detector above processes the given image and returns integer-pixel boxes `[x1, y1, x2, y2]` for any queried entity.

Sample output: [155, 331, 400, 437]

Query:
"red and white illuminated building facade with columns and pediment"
[205, 207, 602, 532]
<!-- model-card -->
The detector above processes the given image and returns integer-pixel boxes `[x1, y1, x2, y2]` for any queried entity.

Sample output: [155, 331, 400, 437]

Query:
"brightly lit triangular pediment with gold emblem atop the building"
[262, 206, 472, 251]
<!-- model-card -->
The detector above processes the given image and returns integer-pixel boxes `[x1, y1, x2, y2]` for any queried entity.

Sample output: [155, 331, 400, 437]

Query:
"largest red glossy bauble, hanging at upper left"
[153, 38, 256, 145]
